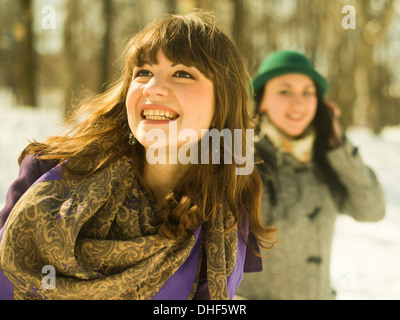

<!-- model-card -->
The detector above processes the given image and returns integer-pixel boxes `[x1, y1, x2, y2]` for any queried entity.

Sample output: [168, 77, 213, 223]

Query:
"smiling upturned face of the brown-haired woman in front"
[126, 50, 214, 149]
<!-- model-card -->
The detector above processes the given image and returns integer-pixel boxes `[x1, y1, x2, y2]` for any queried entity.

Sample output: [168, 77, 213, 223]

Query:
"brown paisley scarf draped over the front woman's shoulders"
[0, 157, 238, 299]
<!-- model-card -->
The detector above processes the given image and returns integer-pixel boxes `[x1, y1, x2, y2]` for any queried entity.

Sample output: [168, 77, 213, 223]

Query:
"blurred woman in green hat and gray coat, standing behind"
[237, 51, 385, 299]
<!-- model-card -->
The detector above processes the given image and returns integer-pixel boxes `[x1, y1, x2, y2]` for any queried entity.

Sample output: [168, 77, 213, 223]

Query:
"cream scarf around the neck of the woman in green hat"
[260, 116, 315, 162]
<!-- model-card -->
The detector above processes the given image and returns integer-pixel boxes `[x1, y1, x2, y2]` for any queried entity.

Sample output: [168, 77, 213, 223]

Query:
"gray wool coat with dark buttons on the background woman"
[237, 137, 385, 300]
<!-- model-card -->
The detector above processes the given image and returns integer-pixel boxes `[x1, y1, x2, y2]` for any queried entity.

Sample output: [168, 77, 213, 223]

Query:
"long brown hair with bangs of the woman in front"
[21, 12, 274, 247]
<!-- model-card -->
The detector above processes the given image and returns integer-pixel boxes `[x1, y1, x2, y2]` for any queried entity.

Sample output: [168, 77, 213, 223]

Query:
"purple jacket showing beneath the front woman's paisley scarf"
[0, 156, 262, 300]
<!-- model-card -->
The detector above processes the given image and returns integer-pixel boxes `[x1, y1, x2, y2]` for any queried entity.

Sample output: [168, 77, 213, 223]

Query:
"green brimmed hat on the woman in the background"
[253, 51, 328, 94]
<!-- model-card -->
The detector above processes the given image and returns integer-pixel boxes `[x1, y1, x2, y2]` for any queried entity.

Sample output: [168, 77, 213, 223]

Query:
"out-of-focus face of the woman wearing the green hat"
[259, 73, 317, 137]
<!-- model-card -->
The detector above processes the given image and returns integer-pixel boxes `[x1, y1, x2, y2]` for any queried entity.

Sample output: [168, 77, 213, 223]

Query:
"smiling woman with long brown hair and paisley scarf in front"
[0, 12, 274, 299]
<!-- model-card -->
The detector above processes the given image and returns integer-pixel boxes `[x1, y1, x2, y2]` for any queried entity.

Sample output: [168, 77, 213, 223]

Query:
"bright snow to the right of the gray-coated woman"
[332, 127, 400, 300]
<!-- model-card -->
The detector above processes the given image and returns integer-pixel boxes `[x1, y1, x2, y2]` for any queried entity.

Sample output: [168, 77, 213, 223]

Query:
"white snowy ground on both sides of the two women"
[0, 89, 400, 300]
